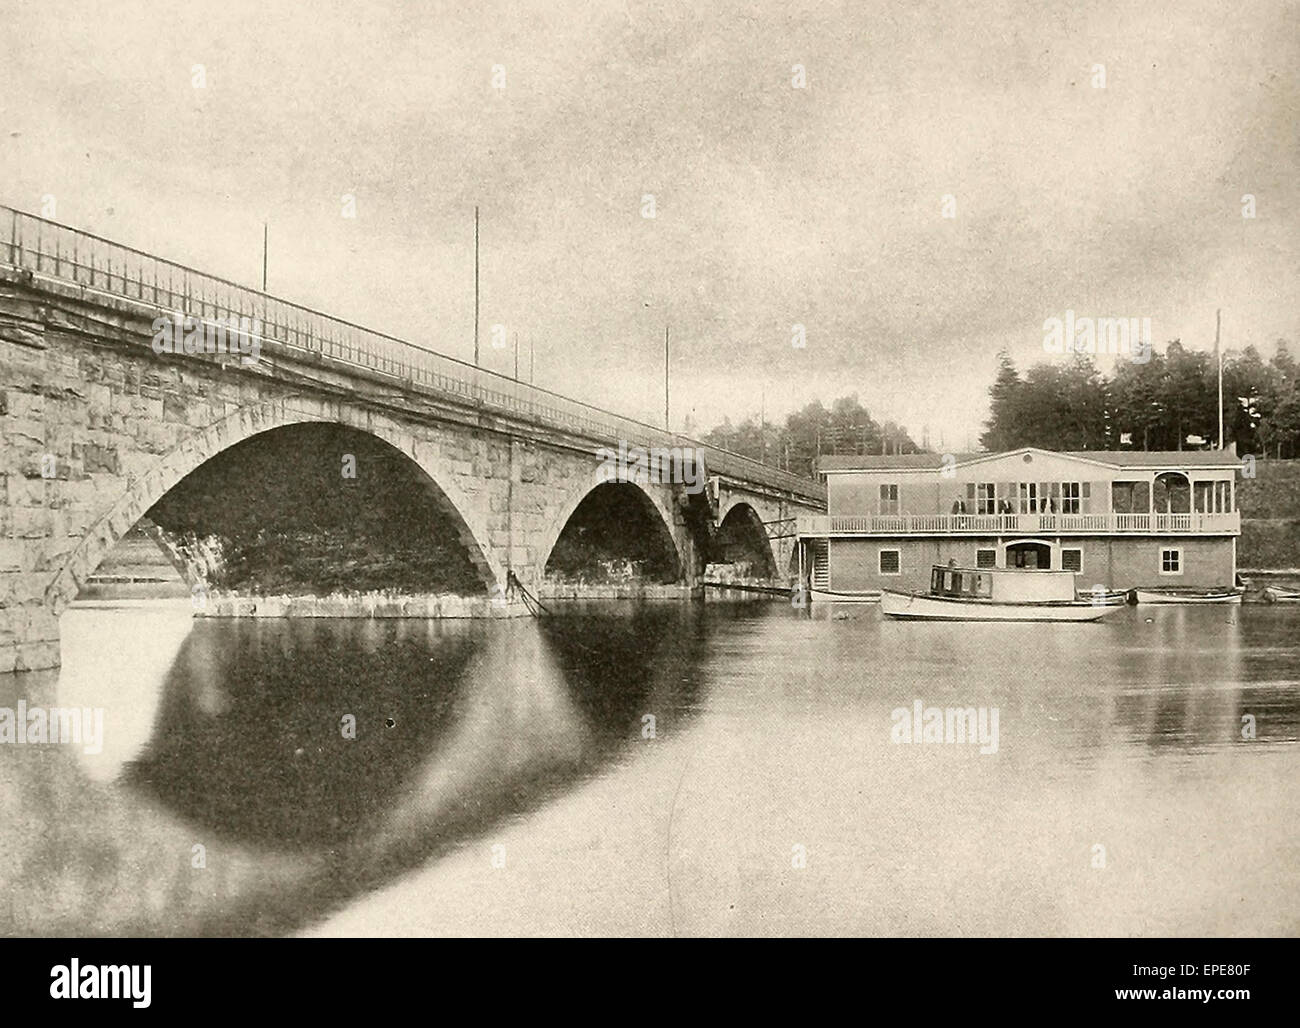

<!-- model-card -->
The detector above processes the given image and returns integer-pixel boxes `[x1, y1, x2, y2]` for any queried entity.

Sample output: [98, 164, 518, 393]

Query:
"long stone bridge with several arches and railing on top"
[0, 208, 826, 672]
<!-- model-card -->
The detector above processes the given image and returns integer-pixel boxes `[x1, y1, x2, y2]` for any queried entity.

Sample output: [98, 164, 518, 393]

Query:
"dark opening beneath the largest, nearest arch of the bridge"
[79, 421, 494, 597]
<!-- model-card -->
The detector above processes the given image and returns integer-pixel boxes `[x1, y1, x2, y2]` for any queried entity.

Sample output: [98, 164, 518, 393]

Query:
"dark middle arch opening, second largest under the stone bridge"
[543, 482, 683, 584]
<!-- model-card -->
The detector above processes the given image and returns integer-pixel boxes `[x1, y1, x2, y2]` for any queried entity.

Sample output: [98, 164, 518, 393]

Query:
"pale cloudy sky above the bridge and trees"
[0, 0, 1300, 448]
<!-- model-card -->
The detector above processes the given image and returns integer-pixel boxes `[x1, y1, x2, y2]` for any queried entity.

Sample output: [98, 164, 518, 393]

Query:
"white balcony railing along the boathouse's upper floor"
[798, 511, 1242, 535]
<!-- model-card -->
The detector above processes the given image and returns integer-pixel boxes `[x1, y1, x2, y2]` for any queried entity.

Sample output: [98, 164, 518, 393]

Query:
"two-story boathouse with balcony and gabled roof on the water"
[798, 447, 1242, 599]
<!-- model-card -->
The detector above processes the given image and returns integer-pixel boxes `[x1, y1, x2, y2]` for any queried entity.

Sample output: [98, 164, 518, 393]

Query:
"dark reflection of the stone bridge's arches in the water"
[0, 602, 703, 934]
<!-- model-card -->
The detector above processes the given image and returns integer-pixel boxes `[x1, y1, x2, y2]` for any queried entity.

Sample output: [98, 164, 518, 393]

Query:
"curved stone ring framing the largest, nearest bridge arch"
[44, 396, 506, 617]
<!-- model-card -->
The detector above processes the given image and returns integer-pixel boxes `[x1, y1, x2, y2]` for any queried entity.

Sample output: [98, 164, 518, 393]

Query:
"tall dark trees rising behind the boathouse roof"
[980, 339, 1300, 456]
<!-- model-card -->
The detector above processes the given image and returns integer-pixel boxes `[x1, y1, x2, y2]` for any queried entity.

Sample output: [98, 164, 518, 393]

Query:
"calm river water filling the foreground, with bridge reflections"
[0, 600, 1300, 936]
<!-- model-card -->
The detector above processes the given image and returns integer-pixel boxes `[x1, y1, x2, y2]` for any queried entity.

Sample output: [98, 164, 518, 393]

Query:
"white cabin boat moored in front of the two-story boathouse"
[880, 565, 1125, 621]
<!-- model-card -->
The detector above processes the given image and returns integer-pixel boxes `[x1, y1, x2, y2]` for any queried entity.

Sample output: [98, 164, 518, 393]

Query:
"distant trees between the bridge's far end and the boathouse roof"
[703, 394, 919, 474]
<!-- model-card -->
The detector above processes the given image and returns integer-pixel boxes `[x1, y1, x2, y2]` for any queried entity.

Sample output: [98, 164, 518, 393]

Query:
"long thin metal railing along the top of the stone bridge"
[0, 205, 826, 503]
